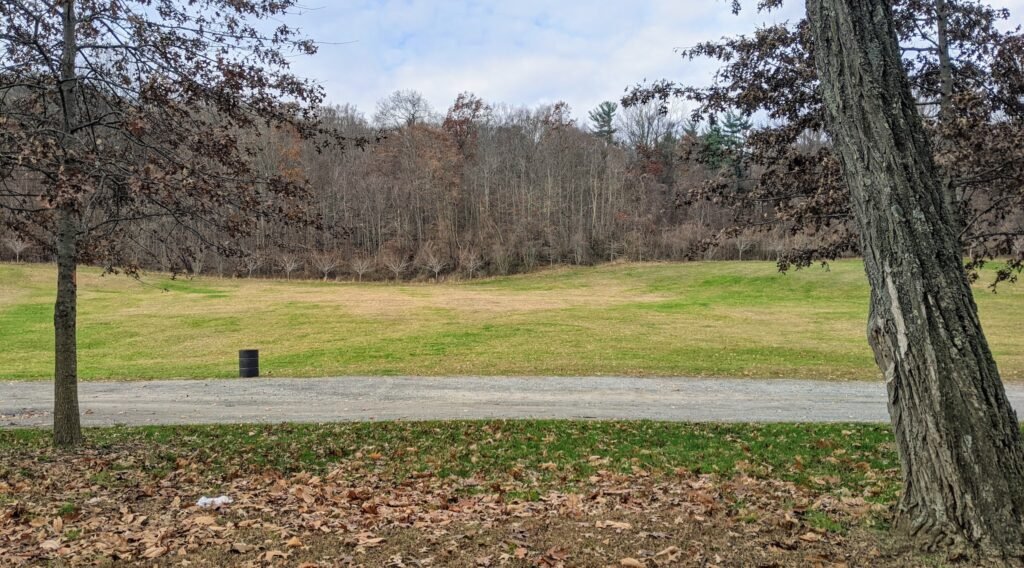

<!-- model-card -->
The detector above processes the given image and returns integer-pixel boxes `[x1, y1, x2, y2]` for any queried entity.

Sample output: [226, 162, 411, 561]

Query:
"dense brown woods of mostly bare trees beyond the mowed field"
[3, 91, 820, 279]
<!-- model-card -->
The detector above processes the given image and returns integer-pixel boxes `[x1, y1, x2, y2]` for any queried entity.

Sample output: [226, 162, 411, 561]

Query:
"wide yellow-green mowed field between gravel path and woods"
[0, 261, 1024, 380]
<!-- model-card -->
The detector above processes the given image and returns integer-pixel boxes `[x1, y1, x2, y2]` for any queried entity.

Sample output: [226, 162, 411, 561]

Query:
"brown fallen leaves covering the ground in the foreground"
[0, 448, 913, 568]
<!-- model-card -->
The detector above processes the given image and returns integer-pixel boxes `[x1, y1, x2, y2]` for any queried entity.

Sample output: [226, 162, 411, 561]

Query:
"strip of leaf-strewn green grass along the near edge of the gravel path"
[0, 421, 899, 501]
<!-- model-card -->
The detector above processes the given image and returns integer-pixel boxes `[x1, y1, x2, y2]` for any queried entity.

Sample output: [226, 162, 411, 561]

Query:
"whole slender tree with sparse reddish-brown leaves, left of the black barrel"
[0, 0, 337, 446]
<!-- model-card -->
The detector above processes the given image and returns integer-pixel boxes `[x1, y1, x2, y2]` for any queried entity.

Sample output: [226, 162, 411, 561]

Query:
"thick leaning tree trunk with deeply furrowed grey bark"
[807, 0, 1024, 559]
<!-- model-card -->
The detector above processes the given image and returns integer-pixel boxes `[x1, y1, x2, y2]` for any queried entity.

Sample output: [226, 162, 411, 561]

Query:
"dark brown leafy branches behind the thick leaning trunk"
[623, 0, 1024, 279]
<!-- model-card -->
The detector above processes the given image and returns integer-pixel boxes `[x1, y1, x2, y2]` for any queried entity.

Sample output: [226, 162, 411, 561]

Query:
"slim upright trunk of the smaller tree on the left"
[53, 0, 82, 447]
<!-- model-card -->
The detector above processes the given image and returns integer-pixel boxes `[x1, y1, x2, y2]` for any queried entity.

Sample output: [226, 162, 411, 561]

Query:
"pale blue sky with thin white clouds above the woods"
[285, 0, 1024, 123]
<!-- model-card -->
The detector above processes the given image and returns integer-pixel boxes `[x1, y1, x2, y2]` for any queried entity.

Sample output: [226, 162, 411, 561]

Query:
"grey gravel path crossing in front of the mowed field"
[6, 377, 1024, 427]
